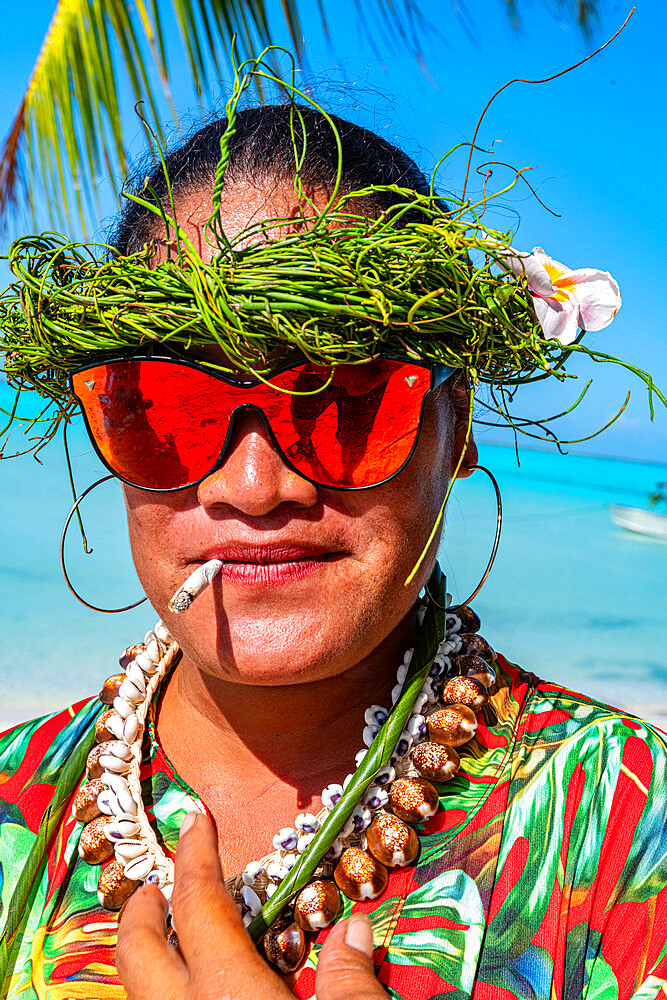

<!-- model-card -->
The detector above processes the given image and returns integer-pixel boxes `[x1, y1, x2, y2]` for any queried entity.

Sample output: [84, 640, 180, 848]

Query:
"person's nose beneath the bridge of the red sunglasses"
[197, 410, 318, 517]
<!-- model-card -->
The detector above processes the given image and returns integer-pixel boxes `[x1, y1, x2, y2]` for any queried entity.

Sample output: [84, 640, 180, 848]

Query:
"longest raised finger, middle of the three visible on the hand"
[172, 813, 265, 979]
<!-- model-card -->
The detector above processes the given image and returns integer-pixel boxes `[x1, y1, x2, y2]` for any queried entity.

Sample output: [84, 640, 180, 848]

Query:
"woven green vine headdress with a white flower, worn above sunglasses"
[0, 52, 667, 468]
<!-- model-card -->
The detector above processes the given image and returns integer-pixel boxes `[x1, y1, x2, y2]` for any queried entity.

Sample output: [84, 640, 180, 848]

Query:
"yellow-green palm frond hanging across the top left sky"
[0, 0, 428, 232]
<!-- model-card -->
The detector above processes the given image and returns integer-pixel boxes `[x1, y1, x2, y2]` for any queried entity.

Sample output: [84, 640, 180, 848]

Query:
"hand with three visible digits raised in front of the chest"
[116, 814, 387, 1000]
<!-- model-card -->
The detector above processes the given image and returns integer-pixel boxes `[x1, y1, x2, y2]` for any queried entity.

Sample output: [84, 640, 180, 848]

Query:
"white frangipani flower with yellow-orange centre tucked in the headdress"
[504, 247, 621, 344]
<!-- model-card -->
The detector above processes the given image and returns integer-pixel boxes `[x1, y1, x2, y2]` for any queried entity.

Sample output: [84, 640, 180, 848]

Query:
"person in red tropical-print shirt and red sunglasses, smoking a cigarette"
[0, 99, 667, 1000]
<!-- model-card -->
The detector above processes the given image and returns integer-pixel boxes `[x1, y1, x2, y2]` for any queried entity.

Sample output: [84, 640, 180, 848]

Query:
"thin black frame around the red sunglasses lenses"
[68, 353, 458, 493]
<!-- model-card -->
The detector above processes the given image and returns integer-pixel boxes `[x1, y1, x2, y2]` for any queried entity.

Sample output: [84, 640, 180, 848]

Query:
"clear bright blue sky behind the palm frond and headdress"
[0, 0, 667, 462]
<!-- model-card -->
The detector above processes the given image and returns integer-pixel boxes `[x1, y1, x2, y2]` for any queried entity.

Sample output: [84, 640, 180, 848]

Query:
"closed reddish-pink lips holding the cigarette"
[190, 542, 346, 586]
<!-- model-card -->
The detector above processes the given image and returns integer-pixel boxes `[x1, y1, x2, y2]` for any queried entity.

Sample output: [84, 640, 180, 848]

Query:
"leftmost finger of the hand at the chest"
[116, 885, 187, 1000]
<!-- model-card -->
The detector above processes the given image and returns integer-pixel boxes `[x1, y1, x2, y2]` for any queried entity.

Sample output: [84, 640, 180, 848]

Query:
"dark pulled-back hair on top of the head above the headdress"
[109, 104, 430, 254]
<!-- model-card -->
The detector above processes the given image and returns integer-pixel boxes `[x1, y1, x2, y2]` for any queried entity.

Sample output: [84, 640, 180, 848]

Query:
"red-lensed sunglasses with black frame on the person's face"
[70, 357, 455, 491]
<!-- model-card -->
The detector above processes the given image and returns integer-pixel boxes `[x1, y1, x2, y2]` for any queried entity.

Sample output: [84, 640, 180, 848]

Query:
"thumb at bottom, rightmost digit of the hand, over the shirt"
[315, 913, 387, 1000]
